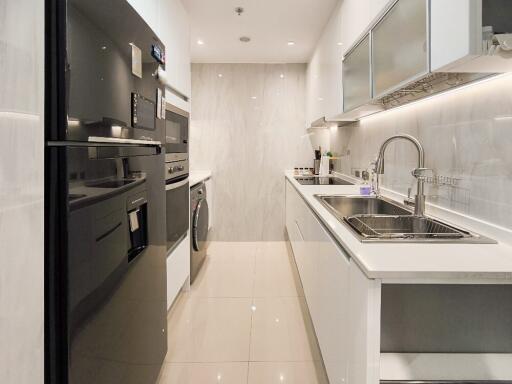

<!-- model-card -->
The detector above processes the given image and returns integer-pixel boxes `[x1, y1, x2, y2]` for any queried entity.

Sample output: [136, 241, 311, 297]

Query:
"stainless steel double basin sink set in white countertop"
[315, 195, 495, 244]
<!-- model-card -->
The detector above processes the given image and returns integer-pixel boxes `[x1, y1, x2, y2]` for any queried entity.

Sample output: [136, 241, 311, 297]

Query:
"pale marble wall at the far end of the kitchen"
[190, 64, 313, 241]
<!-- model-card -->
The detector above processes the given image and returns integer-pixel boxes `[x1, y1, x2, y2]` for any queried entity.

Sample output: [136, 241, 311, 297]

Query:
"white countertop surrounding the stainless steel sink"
[286, 171, 512, 284]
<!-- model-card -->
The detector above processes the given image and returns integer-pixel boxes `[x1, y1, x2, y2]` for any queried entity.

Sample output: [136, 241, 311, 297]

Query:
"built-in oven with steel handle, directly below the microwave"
[165, 153, 189, 255]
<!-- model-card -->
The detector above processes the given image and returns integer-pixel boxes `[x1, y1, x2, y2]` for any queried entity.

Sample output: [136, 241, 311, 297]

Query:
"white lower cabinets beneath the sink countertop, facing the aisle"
[286, 181, 380, 384]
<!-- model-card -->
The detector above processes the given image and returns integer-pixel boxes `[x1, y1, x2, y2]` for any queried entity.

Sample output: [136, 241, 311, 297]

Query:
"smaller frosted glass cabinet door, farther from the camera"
[343, 35, 371, 112]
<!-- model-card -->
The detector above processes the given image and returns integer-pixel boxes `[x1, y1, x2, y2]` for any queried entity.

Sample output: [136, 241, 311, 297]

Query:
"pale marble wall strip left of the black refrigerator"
[0, 0, 44, 384]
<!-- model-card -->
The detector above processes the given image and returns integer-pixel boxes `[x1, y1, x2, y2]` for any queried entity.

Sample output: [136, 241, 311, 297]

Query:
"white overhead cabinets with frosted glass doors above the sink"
[336, 0, 512, 121]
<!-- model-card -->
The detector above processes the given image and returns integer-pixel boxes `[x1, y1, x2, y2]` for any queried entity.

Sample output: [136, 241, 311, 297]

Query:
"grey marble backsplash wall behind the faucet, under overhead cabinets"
[331, 75, 512, 228]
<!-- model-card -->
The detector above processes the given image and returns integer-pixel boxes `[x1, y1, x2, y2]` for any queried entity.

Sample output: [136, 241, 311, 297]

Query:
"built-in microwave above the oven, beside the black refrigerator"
[165, 104, 189, 161]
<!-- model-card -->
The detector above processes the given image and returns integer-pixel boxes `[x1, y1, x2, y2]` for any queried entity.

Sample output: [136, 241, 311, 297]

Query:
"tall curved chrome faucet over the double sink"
[374, 134, 432, 216]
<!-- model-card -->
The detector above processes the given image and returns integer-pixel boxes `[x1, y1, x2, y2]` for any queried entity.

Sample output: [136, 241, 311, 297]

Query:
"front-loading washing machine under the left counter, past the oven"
[190, 183, 209, 282]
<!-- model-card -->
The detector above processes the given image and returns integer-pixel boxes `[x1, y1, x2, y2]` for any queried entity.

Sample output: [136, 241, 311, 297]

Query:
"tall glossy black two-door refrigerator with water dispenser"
[45, 0, 167, 384]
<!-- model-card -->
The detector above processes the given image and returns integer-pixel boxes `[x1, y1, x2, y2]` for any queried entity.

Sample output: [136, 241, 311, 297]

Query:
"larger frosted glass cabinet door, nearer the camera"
[372, 0, 429, 97]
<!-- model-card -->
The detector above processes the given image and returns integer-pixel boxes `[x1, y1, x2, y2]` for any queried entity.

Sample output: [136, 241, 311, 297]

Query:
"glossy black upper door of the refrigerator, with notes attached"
[63, 0, 165, 141]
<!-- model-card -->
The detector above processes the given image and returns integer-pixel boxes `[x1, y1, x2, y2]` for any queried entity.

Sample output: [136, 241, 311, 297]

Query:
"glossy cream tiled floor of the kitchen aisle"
[159, 242, 326, 384]
